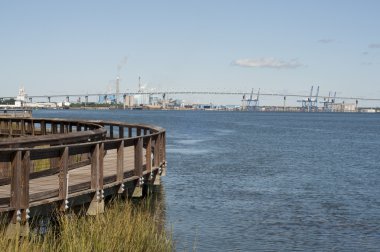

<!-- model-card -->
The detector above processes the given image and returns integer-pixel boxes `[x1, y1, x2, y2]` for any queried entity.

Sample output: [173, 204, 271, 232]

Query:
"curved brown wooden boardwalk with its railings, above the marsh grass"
[0, 118, 166, 235]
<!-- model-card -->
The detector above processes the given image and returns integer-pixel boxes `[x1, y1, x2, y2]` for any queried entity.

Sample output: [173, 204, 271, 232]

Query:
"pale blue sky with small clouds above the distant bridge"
[0, 0, 380, 106]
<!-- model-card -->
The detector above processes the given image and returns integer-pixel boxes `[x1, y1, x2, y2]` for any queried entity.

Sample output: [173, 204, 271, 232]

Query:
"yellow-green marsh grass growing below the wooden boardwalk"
[0, 200, 174, 252]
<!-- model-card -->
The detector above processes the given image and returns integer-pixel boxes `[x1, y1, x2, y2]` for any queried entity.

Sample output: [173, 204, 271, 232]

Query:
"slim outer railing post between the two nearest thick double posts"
[58, 147, 69, 211]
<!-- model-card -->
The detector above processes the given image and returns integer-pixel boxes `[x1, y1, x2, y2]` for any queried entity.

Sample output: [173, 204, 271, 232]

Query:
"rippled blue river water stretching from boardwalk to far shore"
[34, 111, 380, 251]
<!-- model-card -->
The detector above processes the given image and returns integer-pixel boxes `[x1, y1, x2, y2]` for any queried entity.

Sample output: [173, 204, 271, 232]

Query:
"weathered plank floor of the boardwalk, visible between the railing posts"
[0, 146, 145, 207]
